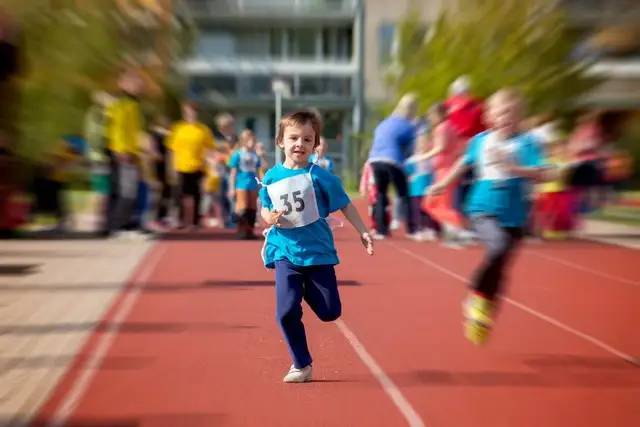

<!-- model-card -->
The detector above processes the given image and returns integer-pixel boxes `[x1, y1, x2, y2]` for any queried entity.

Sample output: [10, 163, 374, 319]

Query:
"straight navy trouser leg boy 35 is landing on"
[276, 260, 312, 369]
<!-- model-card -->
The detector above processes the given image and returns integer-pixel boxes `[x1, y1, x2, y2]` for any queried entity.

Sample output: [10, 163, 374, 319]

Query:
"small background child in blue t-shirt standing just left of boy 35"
[229, 129, 261, 240]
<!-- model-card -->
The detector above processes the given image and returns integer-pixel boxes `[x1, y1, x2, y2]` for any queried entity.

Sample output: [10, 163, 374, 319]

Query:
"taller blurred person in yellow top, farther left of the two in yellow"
[105, 70, 143, 235]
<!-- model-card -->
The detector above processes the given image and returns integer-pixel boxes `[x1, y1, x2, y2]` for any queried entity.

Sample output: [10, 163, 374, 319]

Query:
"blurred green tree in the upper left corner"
[5, 0, 193, 159]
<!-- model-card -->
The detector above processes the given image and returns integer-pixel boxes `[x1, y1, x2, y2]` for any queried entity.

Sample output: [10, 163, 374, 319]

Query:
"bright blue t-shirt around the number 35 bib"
[260, 163, 351, 268]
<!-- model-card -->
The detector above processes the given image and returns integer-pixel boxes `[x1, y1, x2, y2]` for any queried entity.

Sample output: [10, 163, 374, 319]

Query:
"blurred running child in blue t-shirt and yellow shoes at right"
[429, 89, 547, 344]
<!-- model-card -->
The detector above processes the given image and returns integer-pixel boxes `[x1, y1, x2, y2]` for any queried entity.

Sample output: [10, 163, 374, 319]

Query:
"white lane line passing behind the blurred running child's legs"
[387, 242, 640, 365]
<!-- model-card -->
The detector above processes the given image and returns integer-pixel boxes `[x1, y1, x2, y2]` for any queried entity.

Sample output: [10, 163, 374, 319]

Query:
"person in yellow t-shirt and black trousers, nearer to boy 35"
[166, 102, 216, 229]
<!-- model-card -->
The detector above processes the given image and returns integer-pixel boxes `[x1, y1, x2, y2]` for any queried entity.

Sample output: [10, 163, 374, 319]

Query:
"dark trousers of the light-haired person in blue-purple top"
[371, 162, 409, 235]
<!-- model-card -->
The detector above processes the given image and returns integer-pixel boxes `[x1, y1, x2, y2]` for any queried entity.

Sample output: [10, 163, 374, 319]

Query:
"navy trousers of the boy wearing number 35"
[275, 260, 342, 368]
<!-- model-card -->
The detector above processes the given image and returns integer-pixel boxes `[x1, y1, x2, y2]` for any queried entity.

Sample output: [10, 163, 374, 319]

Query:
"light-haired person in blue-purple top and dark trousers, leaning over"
[367, 93, 418, 240]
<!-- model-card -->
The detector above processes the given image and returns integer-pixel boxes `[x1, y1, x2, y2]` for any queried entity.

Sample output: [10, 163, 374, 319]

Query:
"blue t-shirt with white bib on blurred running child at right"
[464, 132, 544, 227]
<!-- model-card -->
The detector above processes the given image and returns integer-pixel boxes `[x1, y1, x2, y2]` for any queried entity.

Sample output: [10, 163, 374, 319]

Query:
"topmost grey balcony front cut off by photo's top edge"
[187, 0, 360, 22]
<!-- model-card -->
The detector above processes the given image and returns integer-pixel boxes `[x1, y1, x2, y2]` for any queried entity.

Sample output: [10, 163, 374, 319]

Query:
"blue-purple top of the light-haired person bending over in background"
[368, 116, 416, 167]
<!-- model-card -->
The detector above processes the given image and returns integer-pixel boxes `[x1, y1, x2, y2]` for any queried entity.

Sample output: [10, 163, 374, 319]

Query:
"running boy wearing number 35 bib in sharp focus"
[260, 111, 373, 383]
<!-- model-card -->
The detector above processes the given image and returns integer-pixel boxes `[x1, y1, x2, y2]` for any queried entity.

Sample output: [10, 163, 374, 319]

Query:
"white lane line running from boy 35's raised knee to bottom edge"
[335, 319, 425, 427]
